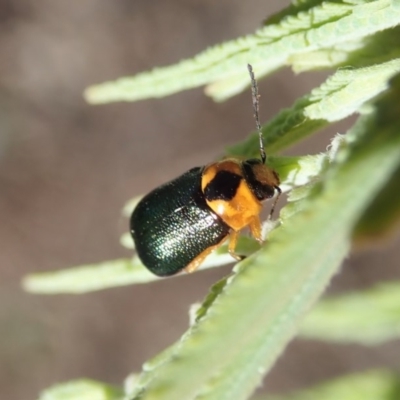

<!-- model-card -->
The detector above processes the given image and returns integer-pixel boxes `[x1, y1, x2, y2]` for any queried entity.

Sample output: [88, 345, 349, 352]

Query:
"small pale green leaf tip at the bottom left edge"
[39, 379, 124, 400]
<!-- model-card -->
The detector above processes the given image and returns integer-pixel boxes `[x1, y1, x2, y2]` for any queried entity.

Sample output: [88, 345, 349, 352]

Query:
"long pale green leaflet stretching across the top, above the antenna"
[85, 0, 400, 103]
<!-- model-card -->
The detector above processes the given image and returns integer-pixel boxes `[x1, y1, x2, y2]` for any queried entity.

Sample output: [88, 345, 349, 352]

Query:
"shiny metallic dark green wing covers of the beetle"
[130, 167, 230, 276]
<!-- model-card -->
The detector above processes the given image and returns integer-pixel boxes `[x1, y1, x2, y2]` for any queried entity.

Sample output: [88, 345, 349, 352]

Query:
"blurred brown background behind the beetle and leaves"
[0, 0, 400, 400]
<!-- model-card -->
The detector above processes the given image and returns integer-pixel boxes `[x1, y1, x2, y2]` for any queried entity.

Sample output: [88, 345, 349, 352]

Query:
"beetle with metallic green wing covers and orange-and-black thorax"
[130, 64, 281, 276]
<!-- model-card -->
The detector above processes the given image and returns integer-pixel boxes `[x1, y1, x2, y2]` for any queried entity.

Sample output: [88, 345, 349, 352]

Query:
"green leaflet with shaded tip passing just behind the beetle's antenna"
[228, 58, 400, 156]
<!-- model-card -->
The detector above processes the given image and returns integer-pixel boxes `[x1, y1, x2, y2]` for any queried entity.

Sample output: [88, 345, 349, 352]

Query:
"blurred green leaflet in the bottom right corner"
[252, 370, 400, 400]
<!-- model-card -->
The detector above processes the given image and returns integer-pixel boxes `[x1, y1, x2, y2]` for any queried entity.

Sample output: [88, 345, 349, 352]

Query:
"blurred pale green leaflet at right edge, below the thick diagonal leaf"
[300, 282, 400, 345]
